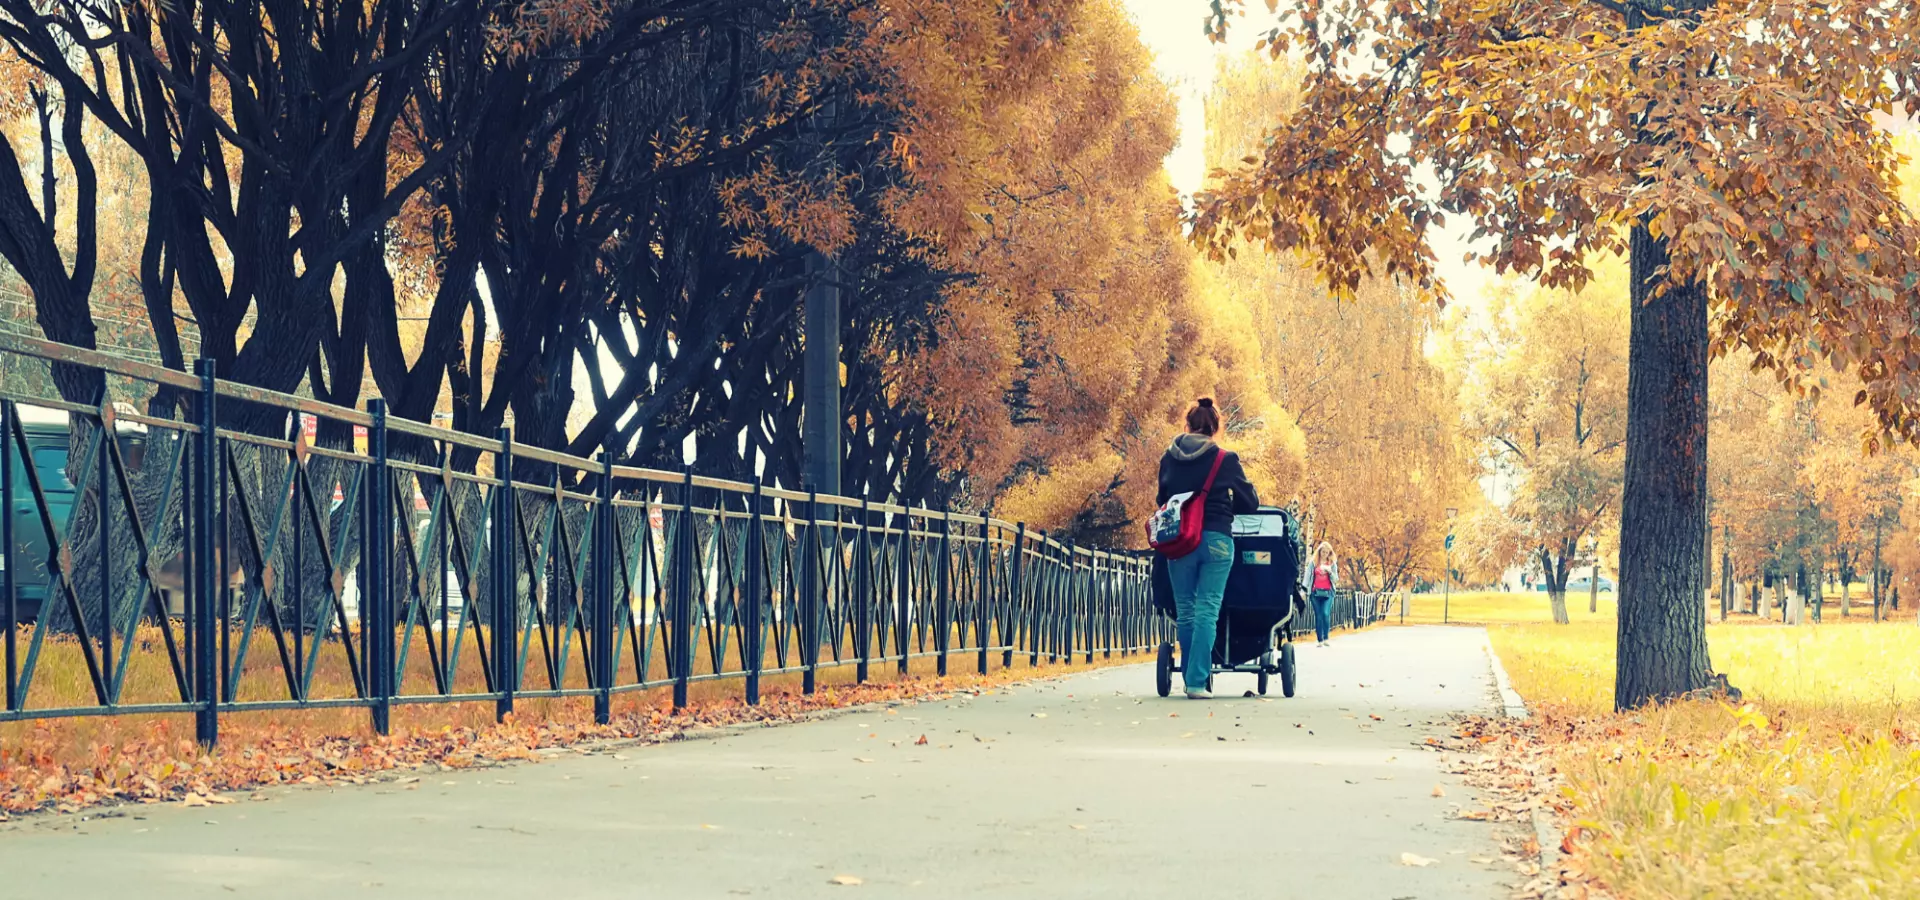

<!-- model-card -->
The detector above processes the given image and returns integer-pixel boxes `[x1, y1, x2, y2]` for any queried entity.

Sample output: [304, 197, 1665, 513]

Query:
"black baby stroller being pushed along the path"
[1154, 507, 1306, 697]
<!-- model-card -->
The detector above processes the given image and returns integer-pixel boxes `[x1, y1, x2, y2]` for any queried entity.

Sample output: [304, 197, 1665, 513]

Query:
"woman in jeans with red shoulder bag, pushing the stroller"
[1154, 397, 1260, 700]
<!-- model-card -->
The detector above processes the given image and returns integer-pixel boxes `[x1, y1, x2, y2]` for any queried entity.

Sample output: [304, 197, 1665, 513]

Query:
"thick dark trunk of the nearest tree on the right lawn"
[1613, 221, 1709, 710]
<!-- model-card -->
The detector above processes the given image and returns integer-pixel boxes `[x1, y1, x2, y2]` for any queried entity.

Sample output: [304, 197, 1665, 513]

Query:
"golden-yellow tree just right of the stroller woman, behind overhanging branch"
[1206, 54, 1465, 591]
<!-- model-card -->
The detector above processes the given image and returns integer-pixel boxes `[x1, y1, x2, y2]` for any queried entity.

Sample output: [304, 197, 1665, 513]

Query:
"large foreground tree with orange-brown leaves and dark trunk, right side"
[1194, 0, 1920, 708]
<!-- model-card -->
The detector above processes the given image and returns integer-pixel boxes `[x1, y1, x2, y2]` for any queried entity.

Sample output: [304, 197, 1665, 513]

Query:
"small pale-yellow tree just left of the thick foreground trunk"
[1455, 263, 1626, 624]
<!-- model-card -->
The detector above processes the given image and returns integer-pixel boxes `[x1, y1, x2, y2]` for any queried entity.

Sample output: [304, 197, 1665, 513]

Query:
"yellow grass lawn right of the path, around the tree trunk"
[1490, 606, 1920, 898]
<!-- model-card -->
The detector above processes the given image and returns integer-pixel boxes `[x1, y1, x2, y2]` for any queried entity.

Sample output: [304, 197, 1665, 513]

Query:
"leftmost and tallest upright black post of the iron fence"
[192, 359, 221, 746]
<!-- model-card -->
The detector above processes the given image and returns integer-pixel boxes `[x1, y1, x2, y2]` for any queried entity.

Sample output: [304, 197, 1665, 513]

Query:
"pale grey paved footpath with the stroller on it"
[0, 628, 1515, 900]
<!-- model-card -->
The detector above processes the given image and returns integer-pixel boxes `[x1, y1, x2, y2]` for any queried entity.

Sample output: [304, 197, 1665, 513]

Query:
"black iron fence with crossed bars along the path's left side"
[0, 336, 1160, 745]
